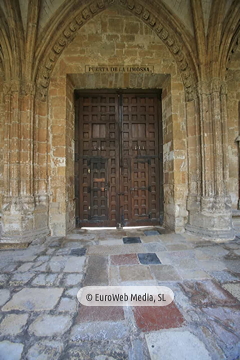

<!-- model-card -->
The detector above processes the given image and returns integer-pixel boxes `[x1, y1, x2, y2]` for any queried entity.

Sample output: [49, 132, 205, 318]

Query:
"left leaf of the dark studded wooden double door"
[78, 94, 119, 226]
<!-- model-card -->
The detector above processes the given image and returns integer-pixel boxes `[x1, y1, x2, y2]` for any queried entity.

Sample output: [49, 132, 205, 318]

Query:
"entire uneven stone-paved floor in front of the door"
[0, 228, 240, 360]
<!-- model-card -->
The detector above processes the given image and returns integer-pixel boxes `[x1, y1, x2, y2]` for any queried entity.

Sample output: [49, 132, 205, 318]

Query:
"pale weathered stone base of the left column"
[0, 196, 49, 249]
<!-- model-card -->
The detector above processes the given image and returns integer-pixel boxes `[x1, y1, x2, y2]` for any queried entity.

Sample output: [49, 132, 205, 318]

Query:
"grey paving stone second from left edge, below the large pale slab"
[28, 315, 72, 336]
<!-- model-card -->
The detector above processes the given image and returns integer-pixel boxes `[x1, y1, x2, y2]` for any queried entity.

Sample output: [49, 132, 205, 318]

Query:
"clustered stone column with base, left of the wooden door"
[0, 81, 48, 247]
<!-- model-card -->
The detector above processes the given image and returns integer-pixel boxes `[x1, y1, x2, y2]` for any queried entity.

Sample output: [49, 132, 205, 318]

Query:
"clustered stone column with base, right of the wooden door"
[186, 78, 234, 240]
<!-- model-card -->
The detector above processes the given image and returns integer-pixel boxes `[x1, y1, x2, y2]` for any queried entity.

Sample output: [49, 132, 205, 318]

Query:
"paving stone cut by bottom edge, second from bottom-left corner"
[26, 340, 63, 360]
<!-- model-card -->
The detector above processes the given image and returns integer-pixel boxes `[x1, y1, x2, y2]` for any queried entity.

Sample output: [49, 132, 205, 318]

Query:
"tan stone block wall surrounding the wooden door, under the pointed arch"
[49, 7, 187, 234]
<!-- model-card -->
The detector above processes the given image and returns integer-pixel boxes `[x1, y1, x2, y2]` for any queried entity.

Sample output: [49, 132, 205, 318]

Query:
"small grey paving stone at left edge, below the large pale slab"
[0, 314, 28, 336]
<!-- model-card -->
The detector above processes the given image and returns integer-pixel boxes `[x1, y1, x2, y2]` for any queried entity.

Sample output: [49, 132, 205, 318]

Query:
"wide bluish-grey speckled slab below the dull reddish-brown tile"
[70, 321, 129, 342]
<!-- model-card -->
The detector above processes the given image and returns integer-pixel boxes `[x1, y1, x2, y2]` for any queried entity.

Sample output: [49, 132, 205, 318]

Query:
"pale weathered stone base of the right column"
[185, 197, 235, 242]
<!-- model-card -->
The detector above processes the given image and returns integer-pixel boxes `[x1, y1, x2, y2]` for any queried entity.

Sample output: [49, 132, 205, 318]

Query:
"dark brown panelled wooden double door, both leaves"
[75, 91, 163, 227]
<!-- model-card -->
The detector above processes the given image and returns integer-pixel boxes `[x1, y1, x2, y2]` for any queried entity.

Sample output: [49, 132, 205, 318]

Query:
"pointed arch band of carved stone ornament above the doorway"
[36, 0, 197, 101]
